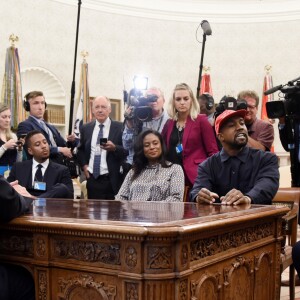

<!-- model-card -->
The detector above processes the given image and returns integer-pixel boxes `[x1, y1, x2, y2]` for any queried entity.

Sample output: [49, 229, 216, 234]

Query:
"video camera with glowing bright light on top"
[124, 89, 158, 122]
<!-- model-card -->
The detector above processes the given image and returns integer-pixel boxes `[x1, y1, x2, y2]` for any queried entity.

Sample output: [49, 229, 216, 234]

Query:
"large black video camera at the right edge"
[264, 77, 300, 119]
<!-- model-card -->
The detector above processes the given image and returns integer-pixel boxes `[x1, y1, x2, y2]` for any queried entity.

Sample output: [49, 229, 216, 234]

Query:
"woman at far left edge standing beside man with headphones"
[0, 103, 24, 175]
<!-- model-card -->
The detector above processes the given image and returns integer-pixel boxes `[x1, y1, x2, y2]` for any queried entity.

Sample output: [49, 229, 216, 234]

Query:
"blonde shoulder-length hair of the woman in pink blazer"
[168, 83, 200, 120]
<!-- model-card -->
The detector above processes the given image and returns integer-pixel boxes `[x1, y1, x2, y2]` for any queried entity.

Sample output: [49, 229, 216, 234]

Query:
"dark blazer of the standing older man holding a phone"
[77, 121, 128, 194]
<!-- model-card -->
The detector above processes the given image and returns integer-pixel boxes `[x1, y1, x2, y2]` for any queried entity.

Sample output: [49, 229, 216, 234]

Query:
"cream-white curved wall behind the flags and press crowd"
[0, 0, 300, 155]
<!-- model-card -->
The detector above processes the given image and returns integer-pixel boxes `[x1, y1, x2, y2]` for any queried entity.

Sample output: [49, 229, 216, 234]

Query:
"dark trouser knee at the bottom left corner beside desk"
[0, 264, 35, 300]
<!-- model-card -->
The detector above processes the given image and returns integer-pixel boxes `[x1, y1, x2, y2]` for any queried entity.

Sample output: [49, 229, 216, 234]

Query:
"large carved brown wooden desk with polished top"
[0, 199, 288, 300]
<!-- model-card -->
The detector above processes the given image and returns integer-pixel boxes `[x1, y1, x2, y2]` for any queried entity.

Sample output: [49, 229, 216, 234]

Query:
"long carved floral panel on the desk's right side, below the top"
[190, 223, 274, 261]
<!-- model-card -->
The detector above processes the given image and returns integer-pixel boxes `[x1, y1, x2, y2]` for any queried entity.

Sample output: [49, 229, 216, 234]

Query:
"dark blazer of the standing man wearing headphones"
[17, 116, 67, 154]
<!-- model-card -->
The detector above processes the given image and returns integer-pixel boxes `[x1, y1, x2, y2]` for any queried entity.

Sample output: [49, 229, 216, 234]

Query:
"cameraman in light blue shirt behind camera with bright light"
[122, 87, 169, 166]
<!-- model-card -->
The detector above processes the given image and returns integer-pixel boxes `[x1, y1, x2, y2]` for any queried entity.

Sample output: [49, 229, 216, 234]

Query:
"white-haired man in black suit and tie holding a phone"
[77, 96, 128, 199]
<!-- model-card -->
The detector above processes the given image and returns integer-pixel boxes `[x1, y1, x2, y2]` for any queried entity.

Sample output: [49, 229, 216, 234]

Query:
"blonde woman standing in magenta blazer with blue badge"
[162, 83, 218, 200]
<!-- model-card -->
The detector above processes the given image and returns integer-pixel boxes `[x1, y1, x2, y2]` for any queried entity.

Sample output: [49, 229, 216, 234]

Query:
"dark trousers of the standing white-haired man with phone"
[86, 174, 115, 200]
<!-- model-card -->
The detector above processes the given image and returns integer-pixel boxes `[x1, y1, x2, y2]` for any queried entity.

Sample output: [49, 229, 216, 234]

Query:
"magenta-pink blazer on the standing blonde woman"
[162, 114, 219, 185]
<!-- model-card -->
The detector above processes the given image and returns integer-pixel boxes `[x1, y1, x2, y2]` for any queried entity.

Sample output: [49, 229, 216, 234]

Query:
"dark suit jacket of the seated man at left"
[7, 159, 74, 198]
